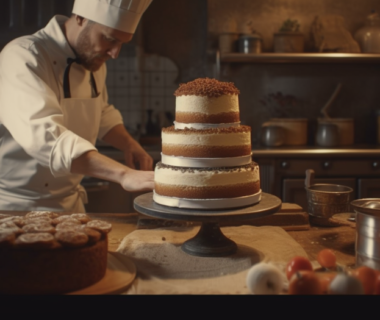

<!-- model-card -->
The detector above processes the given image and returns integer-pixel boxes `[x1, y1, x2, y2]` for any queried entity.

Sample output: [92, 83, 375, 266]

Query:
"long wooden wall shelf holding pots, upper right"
[220, 53, 380, 63]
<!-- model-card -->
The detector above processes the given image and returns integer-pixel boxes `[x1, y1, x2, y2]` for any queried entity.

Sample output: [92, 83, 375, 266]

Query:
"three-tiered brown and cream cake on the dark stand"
[153, 78, 261, 209]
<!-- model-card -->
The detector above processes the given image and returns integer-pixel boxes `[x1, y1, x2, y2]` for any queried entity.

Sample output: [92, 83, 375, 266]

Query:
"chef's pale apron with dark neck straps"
[0, 59, 103, 213]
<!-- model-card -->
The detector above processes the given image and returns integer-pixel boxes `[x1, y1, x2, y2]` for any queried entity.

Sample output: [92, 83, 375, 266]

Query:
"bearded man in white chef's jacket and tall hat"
[0, 0, 154, 213]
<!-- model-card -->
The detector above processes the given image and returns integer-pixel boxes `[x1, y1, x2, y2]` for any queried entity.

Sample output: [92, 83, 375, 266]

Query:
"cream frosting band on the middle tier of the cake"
[161, 131, 251, 146]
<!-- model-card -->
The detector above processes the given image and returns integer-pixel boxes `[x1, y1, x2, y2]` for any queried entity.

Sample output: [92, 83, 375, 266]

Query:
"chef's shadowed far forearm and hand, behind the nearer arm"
[102, 124, 153, 170]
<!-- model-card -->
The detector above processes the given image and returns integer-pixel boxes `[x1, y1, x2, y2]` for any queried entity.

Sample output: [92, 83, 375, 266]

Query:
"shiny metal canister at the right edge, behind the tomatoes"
[351, 198, 380, 270]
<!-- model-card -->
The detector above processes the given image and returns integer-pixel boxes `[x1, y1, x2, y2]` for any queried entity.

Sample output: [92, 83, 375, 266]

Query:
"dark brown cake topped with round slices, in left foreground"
[0, 211, 112, 294]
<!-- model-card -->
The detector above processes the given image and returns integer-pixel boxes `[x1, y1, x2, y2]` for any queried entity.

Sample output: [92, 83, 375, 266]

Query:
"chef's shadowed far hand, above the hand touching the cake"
[124, 139, 153, 171]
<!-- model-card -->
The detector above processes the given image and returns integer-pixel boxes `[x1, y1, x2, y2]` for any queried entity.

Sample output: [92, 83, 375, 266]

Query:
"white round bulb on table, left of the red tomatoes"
[246, 262, 284, 294]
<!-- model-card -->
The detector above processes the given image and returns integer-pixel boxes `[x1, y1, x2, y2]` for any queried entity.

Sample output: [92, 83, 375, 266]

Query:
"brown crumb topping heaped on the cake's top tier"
[174, 78, 240, 98]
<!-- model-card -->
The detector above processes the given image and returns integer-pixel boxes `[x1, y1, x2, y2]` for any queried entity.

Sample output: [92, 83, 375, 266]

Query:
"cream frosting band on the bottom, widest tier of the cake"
[154, 166, 259, 187]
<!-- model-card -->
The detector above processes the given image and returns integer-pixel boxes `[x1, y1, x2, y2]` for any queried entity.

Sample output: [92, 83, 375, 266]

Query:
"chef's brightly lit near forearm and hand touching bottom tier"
[71, 150, 154, 192]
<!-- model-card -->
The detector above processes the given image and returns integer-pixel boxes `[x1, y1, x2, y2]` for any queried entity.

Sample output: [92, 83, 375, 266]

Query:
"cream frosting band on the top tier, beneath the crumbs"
[175, 94, 239, 114]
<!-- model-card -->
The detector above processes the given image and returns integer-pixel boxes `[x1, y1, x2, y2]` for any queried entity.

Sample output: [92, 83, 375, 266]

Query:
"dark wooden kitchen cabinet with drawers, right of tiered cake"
[252, 148, 380, 210]
